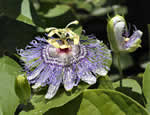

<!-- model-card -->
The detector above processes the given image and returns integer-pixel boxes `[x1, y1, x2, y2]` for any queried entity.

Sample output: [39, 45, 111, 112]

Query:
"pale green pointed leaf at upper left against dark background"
[17, 0, 35, 26]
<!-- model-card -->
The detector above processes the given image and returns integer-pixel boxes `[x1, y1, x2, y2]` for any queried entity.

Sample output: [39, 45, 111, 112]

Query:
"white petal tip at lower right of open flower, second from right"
[81, 72, 96, 84]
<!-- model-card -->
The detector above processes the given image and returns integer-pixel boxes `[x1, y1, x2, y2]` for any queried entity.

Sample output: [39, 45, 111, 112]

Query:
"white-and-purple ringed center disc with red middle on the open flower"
[42, 45, 87, 66]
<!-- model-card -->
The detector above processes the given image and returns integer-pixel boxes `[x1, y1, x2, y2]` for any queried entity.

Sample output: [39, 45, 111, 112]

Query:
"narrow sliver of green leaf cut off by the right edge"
[143, 64, 150, 111]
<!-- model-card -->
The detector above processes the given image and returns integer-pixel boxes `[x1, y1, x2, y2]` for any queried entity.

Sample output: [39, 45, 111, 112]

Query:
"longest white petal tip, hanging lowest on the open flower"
[45, 83, 60, 99]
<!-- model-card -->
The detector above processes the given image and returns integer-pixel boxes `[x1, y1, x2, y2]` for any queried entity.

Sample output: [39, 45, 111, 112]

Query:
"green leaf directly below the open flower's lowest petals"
[20, 83, 89, 115]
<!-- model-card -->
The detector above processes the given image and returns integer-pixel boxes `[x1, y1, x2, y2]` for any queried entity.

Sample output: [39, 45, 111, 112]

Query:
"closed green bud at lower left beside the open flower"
[15, 75, 31, 104]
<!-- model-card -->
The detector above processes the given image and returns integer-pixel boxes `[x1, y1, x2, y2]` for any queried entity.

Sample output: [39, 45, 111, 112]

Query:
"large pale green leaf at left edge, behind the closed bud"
[0, 56, 21, 115]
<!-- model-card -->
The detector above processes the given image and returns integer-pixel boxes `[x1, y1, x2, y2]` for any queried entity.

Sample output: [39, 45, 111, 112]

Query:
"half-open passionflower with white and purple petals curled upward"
[107, 15, 143, 52]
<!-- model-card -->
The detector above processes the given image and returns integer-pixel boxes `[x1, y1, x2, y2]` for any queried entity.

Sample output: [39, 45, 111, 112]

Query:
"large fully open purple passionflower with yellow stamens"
[18, 21, 111, 99]
